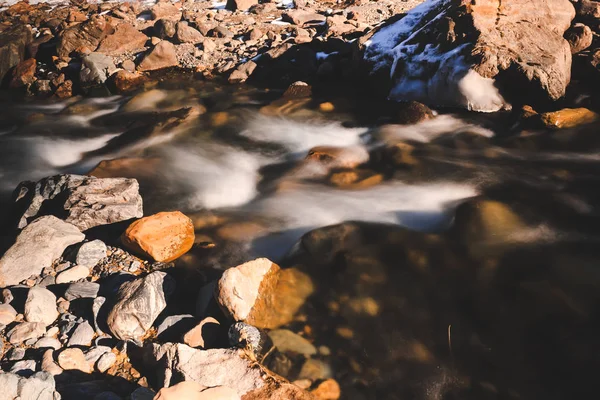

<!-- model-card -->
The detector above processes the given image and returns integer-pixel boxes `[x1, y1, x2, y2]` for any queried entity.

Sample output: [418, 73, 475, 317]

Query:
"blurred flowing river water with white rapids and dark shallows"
[0, 81, 600, 399]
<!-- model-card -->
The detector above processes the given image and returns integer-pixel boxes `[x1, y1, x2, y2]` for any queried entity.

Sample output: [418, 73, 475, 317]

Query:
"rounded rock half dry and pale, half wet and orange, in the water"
[215, 258, 314, 329]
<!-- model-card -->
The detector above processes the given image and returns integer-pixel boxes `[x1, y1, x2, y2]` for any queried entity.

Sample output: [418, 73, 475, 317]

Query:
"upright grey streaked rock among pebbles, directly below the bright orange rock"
[107, 271, 175, 340]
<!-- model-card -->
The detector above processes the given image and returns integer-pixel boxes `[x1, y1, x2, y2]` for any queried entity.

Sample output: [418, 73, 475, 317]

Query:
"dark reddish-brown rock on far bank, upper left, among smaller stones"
[56, 16, 111, 57]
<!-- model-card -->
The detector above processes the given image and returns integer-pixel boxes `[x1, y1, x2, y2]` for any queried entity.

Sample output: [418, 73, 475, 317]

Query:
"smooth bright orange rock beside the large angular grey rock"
[121, 211, 194, 262]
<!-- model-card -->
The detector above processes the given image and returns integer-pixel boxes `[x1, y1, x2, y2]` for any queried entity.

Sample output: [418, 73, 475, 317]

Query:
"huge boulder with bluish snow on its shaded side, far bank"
[364, 0, 575, 112]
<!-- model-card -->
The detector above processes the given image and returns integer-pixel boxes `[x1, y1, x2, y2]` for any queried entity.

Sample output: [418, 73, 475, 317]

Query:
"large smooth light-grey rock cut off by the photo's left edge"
[0, 216, 85, 287]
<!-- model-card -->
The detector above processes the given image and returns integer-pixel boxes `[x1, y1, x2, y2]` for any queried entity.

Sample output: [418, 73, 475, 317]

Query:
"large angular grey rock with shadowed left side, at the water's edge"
[15, 175, 144, 231]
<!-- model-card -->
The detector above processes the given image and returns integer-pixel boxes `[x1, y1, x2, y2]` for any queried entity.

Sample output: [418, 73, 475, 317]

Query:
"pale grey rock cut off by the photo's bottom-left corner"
[0, 372, 60, 400]
